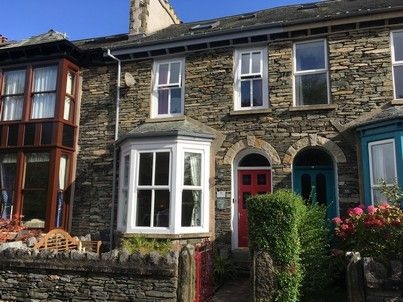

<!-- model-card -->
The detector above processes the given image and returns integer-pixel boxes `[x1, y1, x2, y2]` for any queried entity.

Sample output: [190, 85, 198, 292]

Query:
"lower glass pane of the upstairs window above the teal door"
[295, 73, 328, 105]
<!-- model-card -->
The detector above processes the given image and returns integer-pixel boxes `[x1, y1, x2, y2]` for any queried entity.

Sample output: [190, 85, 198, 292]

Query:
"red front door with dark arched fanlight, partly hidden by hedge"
[235, 153, 272, 248]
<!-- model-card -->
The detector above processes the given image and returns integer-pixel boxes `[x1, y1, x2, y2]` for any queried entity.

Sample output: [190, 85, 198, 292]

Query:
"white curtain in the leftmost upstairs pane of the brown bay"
[3, 70, 25, 121]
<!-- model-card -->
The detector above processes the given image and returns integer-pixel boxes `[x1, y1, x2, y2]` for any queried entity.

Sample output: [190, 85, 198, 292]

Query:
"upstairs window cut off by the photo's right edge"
[391, 31, 403, 99]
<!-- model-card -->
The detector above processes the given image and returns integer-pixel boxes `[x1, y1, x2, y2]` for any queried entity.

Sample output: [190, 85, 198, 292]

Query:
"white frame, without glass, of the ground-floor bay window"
[117, 138, 211, 234]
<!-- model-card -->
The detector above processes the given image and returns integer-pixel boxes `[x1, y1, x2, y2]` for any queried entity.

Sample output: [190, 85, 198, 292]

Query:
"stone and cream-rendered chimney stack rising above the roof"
[129, 0, 180, 35]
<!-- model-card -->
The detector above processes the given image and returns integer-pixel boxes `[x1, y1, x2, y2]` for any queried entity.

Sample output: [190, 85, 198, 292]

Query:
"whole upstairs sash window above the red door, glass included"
[234, 48, 268, 110]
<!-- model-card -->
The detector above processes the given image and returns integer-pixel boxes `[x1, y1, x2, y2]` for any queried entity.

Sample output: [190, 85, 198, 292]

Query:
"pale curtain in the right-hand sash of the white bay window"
[188, 153, 201, 226]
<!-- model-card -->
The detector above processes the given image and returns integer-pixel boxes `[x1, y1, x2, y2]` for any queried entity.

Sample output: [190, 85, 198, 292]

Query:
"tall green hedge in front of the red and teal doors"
[247, 190, 329, 302]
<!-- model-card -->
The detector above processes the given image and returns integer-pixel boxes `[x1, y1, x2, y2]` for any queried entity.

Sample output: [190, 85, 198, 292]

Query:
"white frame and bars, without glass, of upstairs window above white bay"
[151, 58, 185, 118]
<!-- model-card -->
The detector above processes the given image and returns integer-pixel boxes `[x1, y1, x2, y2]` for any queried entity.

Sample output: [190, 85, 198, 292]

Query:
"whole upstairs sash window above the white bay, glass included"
[151, 59, 185, 117]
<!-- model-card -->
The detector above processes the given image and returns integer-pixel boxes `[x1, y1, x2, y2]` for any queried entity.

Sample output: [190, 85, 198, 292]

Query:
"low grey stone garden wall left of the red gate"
[0, 249, 183, 302]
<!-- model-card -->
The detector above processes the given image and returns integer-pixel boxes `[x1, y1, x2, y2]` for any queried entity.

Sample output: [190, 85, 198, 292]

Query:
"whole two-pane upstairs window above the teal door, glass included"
[294, 40, 329, 106]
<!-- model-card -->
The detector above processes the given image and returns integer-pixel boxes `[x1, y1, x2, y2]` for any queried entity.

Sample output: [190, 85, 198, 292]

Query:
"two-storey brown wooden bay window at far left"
[0, 59, 79, 229]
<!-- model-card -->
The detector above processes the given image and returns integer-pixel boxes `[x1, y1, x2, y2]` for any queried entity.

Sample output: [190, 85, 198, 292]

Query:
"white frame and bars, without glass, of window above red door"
[234, 47, 269, 110]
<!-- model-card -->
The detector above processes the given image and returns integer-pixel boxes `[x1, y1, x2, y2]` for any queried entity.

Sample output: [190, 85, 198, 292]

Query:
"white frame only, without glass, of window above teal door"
[293, 39, 330, 107]
